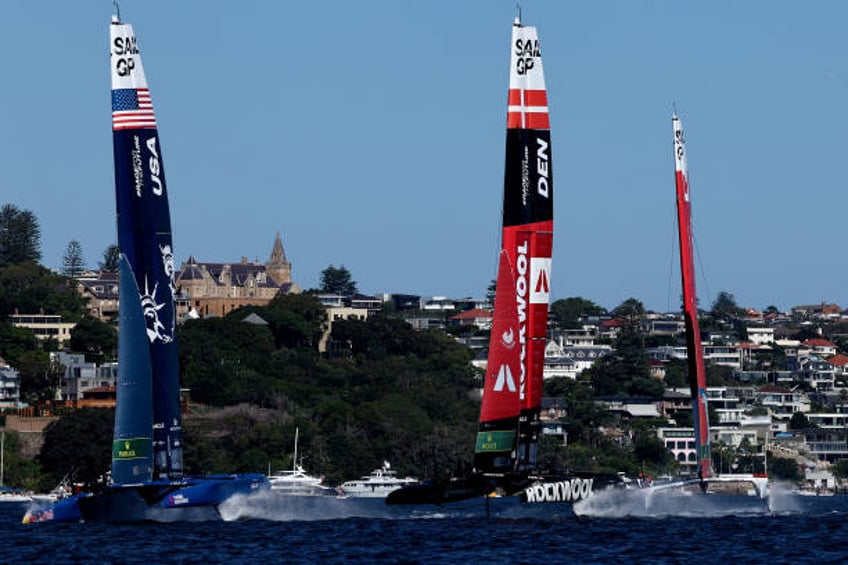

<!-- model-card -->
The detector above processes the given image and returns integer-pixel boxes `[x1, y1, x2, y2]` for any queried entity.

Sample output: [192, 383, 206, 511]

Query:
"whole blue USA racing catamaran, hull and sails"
[23, 8, 269, 523]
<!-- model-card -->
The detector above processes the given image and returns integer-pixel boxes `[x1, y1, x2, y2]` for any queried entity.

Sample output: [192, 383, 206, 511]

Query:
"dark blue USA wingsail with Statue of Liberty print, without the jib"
[110, 18, 183, 480]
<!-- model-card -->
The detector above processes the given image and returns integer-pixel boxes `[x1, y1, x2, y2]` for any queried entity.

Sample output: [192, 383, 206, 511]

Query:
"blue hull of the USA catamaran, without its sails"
[23, 473, 270, 524]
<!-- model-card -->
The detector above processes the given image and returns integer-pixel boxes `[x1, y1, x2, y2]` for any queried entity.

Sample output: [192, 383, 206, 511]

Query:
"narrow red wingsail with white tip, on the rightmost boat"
[671, 113, 713, 479]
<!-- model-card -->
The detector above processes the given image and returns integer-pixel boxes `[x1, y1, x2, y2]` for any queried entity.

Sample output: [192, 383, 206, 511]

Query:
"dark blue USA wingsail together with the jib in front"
[110, 16, 183, 484]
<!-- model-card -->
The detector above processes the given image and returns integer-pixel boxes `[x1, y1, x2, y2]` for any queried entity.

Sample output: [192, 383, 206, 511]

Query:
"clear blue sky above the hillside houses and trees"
[0, 0, 848, 310]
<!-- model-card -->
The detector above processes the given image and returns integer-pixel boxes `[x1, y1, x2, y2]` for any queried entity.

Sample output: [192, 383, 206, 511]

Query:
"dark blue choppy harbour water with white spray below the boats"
[0, 486, 848, 565]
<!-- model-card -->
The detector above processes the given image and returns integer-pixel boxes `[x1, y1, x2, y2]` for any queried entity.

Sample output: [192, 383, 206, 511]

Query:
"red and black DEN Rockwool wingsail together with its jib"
[474, 20, 553, 472]
